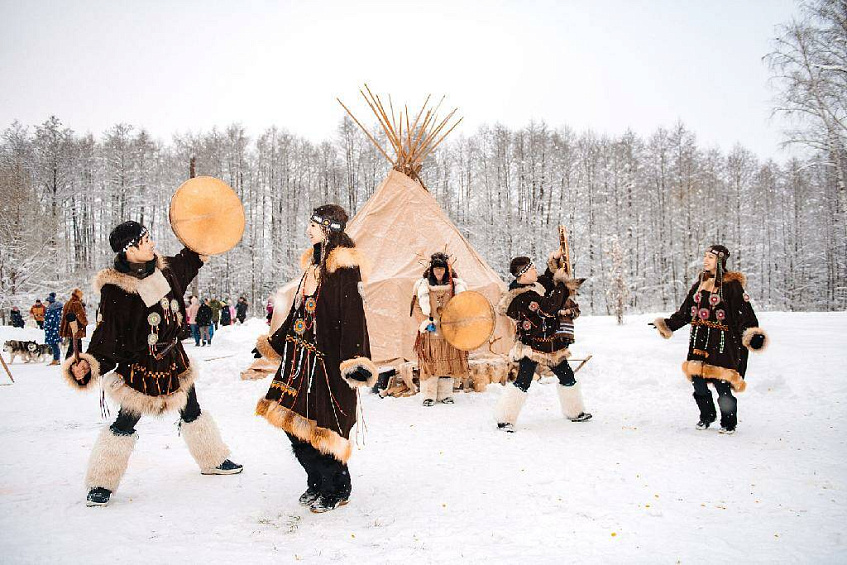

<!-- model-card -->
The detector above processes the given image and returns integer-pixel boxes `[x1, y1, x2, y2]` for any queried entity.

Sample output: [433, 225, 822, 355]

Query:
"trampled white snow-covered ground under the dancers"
[0, 313, 847, 564]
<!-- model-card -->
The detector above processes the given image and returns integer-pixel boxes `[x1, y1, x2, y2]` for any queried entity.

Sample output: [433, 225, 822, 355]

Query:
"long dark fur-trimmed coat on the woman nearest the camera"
[256, 242, 378, 463]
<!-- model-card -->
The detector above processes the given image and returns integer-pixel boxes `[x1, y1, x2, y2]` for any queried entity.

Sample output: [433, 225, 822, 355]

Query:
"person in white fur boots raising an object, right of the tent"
[495, 250, 591, 432]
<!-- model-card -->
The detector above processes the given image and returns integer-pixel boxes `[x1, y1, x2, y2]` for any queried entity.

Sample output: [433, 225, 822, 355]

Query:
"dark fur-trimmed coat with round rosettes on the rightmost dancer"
[653, 271, 768, 392]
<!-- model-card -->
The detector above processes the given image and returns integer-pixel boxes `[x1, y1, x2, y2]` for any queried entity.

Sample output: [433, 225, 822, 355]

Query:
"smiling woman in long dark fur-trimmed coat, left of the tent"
[256, 204, 378, 513]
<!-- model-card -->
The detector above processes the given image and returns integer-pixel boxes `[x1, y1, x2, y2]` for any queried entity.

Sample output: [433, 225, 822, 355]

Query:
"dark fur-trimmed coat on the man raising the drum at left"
[62, 248, 204, 415]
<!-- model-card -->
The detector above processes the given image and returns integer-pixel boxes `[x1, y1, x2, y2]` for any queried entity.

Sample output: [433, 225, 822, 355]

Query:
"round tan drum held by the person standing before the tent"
[441, 290, 497, 351]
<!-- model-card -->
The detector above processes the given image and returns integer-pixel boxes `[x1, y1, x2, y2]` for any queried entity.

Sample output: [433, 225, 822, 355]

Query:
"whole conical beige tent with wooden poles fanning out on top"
[264, 85, 513, 364]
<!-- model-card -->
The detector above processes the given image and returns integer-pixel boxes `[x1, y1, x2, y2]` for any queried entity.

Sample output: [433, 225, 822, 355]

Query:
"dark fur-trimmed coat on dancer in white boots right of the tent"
[497, 266, 585, 368]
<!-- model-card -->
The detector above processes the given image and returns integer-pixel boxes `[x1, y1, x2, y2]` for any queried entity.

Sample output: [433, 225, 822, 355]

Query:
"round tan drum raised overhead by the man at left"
[170, 177, 245, 255]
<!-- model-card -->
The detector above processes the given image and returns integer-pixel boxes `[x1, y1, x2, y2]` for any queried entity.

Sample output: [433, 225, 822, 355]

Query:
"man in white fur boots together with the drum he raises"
[62, 177, 244, 506]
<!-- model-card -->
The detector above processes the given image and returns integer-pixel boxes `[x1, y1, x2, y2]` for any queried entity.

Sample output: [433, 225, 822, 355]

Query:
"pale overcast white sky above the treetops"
[0, 0, 798, 159]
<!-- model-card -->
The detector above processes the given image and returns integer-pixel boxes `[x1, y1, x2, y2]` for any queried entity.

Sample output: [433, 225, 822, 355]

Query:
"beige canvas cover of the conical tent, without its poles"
[271, 170, 513, 364]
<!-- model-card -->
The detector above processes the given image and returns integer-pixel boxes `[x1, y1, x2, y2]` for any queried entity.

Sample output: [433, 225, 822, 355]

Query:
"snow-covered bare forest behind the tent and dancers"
[0, 1, 847, 316]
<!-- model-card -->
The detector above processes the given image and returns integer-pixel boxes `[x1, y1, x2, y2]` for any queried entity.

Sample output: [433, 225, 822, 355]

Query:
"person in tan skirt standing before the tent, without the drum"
[412, 253, 469, 406]
